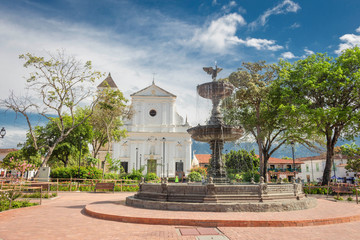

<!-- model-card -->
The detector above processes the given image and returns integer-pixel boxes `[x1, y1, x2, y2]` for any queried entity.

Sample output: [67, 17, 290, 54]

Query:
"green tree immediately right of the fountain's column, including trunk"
[222, 61, 287, 177]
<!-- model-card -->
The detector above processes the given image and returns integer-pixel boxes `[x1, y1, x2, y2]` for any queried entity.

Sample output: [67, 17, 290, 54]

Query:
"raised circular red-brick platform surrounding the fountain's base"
[84, 199, 360, 227]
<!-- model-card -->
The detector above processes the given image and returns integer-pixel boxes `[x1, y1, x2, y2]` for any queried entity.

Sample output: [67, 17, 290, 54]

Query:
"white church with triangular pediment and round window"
[99, 74, 192, 177]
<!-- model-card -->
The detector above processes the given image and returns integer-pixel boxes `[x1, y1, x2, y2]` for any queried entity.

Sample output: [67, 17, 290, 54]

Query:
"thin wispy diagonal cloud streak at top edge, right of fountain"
[249, 0, 300, 28]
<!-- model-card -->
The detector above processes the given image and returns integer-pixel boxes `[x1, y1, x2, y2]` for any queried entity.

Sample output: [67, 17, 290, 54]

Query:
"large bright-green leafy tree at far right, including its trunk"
[274, 47, 360, 185]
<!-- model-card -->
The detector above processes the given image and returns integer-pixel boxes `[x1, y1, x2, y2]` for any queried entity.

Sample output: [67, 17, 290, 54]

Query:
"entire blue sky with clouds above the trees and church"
[0, 0, 360, 147]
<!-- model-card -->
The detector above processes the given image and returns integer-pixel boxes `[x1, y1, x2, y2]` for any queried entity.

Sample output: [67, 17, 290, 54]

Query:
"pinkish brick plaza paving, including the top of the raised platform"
[0, 193, 360, 240]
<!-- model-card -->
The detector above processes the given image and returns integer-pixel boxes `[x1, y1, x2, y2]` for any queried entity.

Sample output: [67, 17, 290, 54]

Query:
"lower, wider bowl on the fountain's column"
[187, 125, 243, 142]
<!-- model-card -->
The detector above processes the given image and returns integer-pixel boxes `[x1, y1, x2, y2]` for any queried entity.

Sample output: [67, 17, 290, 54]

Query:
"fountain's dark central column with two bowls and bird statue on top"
[188, 66, 243, 184]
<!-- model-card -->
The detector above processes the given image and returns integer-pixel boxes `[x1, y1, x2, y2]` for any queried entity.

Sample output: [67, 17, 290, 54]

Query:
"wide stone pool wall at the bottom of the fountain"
[126, 183, 316, 212]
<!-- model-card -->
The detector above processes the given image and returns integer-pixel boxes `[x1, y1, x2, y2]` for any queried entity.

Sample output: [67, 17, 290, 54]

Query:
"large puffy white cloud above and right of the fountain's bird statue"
[191, 13, 283, 54]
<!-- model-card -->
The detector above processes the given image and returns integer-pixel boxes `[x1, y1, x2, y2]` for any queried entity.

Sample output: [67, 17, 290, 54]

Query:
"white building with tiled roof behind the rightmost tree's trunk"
[296, 153, 356, 182]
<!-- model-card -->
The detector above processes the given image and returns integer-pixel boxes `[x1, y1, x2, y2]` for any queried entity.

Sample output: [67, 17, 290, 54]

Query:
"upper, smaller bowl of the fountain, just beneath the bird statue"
[197, 81, 234, 99]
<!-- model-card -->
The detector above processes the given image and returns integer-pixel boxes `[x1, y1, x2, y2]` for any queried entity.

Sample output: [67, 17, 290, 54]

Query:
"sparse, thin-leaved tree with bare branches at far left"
[1, 51, 101, 172]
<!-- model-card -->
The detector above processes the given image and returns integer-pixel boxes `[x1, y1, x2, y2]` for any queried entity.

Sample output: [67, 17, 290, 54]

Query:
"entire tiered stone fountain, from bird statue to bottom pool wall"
[126, 66, 316, 212]
